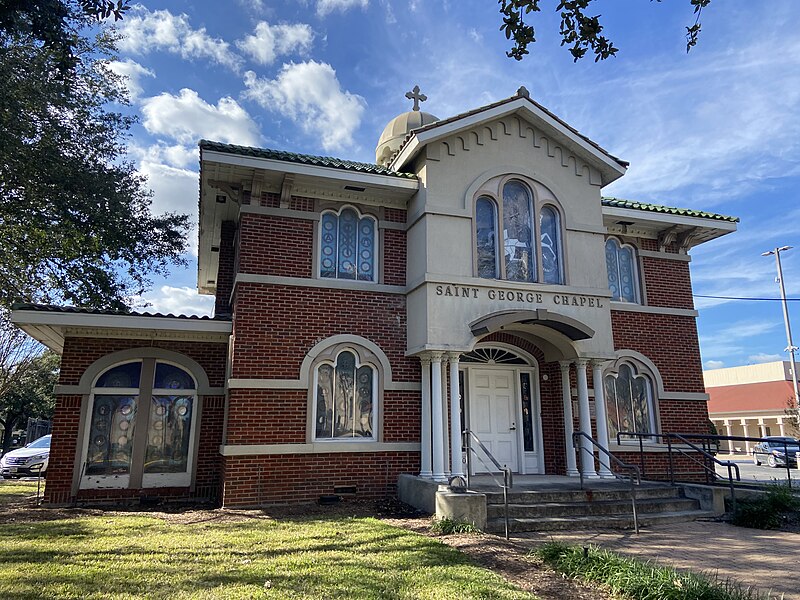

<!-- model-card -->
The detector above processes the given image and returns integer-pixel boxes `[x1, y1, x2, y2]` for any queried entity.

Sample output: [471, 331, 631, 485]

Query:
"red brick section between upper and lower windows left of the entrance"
[232, 283, 412, 381]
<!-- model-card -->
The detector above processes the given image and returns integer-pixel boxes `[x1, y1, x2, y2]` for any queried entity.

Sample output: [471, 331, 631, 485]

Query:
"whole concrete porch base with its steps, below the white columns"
[398, 475, 722, 532]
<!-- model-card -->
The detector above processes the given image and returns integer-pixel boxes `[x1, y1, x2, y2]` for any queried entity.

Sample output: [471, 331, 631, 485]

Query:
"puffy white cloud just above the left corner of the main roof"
[141, 88, 261, 146]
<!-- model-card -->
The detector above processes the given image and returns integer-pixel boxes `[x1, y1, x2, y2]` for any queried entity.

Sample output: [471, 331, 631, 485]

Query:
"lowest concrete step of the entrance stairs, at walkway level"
[486, 510, 715, 533]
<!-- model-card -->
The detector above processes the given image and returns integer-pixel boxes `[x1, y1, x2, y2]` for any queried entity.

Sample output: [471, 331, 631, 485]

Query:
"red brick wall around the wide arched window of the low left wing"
[45, 338, 227, 504]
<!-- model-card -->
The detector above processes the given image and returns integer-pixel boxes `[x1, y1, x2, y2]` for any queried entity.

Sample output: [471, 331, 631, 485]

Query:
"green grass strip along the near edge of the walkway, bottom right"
[534, 542, 777, 600]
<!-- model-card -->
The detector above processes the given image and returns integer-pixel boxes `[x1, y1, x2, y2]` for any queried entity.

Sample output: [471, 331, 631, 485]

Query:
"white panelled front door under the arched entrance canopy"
[469, 369, 519, 473]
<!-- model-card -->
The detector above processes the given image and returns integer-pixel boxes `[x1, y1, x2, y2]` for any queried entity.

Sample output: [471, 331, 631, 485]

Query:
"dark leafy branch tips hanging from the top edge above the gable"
[498, 0, 711, 62]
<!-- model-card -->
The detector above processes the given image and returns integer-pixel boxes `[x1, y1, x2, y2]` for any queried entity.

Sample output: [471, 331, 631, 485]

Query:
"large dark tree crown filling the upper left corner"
[0, 0, 188, 309]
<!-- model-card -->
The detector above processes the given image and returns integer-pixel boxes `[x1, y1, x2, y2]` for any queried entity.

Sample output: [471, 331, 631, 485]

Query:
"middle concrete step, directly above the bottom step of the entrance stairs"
[486, 497, 700, 519]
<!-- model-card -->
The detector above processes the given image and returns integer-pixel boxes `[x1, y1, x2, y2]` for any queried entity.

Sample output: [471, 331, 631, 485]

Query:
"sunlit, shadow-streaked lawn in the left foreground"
[0, 482, 533, 600]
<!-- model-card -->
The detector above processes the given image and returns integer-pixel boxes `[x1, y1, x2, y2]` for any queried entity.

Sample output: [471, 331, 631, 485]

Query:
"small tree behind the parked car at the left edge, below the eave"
[0, 317, 59, 453]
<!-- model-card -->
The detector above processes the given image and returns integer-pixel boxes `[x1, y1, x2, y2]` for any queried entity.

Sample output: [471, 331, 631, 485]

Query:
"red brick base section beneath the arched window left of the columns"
[222, 452, 420, 506]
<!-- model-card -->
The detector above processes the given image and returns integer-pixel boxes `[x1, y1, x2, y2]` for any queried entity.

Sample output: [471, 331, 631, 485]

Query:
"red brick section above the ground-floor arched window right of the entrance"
[611, 310, 705, 393]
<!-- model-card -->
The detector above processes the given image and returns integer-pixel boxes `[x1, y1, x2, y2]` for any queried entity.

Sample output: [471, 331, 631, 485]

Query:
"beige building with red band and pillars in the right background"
[703, 361, 798, 454]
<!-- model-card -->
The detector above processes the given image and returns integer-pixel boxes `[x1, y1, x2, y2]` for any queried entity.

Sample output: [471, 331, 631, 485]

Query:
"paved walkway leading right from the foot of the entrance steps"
[513, 521, 800, 600]
